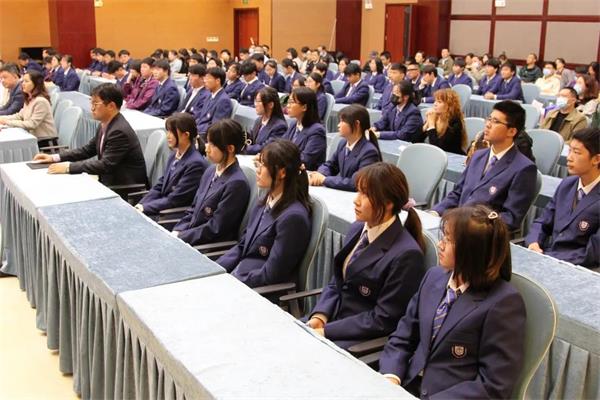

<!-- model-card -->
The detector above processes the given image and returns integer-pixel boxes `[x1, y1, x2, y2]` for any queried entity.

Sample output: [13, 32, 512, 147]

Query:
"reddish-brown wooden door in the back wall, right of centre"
[383, 4, 411, 62]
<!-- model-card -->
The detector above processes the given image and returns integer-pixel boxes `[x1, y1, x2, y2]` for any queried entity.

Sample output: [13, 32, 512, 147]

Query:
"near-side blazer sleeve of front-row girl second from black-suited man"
[179, 180, 250, 247]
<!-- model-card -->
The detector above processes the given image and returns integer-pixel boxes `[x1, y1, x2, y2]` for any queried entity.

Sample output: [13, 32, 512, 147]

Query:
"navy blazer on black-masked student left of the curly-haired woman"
[374, 103, 423, 143]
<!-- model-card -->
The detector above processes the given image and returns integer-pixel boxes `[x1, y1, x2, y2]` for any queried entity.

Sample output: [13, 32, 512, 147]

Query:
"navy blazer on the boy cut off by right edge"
[526, 176, 600, 268]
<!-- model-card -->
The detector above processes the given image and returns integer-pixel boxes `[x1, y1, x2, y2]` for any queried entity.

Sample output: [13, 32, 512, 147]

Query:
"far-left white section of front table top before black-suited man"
[0, 163, 117, 216]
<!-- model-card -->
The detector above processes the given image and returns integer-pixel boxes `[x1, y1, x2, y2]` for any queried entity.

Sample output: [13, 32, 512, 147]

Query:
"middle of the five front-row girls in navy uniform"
[217, 139, 311, 287]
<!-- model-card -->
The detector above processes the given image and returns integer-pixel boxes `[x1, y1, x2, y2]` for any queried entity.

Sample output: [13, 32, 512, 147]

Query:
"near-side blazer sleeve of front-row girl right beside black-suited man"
[141, 163, 204, 214]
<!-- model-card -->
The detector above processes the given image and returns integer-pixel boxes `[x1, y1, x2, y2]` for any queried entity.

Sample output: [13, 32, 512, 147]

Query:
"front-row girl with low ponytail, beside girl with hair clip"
[308, 162, 425, 348]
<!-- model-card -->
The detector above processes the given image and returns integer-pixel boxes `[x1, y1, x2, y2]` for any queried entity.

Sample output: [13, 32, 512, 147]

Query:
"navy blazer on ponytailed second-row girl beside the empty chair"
[318, 136, 381, 192]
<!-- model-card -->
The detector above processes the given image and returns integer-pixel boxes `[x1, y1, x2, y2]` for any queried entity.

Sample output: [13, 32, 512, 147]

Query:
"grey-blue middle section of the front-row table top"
[39, 198, 225, 303]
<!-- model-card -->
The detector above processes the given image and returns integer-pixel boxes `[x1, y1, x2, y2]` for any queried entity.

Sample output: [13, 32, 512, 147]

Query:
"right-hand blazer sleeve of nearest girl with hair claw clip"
[430, 293, 526, 400]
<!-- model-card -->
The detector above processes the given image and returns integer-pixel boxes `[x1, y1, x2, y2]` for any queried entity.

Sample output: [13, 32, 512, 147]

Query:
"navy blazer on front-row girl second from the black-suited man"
[173, 161, 250, 245]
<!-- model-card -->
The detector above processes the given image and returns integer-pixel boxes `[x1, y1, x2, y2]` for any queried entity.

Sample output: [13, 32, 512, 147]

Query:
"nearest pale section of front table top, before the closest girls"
[118, 274, 412, 400]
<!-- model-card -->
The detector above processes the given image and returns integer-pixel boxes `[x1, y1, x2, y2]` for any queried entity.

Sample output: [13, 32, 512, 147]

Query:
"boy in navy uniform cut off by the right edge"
[527, 128, 600, 268]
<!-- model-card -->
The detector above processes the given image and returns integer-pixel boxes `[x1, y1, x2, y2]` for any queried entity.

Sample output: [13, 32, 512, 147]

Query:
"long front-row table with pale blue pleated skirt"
[0, 164, 418, 399]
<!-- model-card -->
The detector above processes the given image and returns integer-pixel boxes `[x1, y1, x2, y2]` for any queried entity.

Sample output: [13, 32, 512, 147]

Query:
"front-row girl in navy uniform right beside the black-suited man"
[135, 113, 208, 217]
